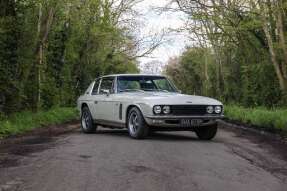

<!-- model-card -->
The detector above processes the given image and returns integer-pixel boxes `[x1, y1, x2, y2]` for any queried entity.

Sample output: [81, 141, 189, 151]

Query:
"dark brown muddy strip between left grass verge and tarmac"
[0, 121, 79, 168]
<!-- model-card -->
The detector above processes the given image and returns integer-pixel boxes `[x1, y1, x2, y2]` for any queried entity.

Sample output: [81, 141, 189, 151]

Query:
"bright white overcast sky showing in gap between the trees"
[135, 0, 187, 70]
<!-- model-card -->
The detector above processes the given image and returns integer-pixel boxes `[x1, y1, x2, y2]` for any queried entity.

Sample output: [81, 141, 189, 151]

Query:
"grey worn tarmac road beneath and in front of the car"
[0, 124, 287, 191]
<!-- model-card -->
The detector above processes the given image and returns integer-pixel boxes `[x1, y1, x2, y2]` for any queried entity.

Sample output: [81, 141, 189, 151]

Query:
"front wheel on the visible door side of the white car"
[126, 107, 149, 139]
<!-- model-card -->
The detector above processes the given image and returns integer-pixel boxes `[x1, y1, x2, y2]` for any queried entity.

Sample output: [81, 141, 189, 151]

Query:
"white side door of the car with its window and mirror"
[96, 77, 115, 121]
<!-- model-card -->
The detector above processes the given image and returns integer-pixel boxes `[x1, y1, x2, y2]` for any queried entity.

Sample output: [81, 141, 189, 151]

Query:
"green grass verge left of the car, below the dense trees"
[0, 107, 78, 138]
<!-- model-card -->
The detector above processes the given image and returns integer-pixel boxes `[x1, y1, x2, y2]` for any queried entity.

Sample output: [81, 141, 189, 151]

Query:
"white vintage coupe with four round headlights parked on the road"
[77, 74, 223, 140]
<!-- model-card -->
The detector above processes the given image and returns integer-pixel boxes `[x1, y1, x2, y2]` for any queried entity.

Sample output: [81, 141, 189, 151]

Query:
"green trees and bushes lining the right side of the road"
[166, 0, 287, 107]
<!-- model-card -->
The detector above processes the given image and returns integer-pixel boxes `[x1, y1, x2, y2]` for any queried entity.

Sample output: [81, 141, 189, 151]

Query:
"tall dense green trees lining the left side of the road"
[0, 0, 141, 115]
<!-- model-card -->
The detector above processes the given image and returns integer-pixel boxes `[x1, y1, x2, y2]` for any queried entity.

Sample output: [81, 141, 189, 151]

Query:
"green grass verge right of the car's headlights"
[224, 105, 287, 135]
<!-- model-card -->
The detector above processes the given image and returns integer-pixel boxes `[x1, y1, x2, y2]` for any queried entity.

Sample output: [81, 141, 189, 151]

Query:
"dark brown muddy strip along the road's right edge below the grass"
[219, 121, 287, 182]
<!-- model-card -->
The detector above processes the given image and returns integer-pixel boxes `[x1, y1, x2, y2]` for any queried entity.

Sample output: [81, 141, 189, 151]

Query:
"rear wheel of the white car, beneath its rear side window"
[81, 106, 97, 133]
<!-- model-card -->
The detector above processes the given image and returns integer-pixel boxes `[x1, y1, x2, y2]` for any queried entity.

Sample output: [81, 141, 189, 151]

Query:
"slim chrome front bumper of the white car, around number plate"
[144, 115, 224, 129]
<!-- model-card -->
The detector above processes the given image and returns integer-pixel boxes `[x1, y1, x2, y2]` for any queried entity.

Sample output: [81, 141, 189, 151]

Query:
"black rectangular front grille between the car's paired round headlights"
[171, 105, 207, 115]
